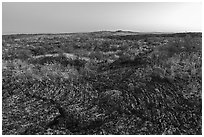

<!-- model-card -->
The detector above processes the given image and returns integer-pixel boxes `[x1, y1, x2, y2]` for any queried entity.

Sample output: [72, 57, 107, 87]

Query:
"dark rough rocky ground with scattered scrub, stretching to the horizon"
[2, 32, 202, 135]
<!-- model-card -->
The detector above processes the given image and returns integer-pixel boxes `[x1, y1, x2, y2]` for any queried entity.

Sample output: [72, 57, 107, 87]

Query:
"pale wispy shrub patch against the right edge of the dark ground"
[153, 52, 202, 100]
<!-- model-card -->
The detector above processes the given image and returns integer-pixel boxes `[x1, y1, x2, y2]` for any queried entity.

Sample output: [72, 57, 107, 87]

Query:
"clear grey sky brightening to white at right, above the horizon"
[2, 2, 202, 34]
